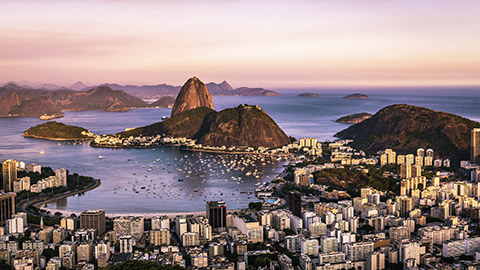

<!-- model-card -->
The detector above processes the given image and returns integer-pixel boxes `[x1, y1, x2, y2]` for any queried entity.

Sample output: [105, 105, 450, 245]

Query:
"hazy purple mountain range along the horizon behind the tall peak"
[0, 81, 280, 99]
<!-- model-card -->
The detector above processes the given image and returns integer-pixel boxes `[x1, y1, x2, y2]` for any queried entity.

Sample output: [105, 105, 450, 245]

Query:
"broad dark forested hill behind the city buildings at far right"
[335, 104, 480, 164]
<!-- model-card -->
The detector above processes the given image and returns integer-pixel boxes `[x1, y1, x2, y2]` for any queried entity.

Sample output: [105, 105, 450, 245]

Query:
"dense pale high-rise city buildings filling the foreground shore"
[0, 129, 480, 270]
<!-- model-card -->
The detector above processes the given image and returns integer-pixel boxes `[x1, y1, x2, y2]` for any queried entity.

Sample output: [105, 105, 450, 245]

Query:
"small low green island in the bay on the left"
[23, 121, 95, 141]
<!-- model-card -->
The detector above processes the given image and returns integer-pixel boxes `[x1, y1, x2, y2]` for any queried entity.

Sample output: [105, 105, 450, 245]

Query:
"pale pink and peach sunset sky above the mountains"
[0, 0, 480, 88]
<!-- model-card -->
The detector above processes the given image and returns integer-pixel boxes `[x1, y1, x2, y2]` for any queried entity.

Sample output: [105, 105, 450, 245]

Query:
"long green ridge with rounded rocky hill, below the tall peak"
[122, 105, 290, 147]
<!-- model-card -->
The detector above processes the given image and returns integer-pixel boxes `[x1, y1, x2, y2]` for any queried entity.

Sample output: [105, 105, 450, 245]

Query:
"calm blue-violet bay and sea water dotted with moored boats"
[0, 94, 480, 213]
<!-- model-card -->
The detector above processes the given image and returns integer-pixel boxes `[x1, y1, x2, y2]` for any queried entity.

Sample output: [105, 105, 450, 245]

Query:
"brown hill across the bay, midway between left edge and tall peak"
[60, 86, 147, 112]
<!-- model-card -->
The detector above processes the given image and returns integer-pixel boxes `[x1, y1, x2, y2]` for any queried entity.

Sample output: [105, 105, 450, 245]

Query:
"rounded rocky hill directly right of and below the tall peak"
[198, 105, 290, 148]
